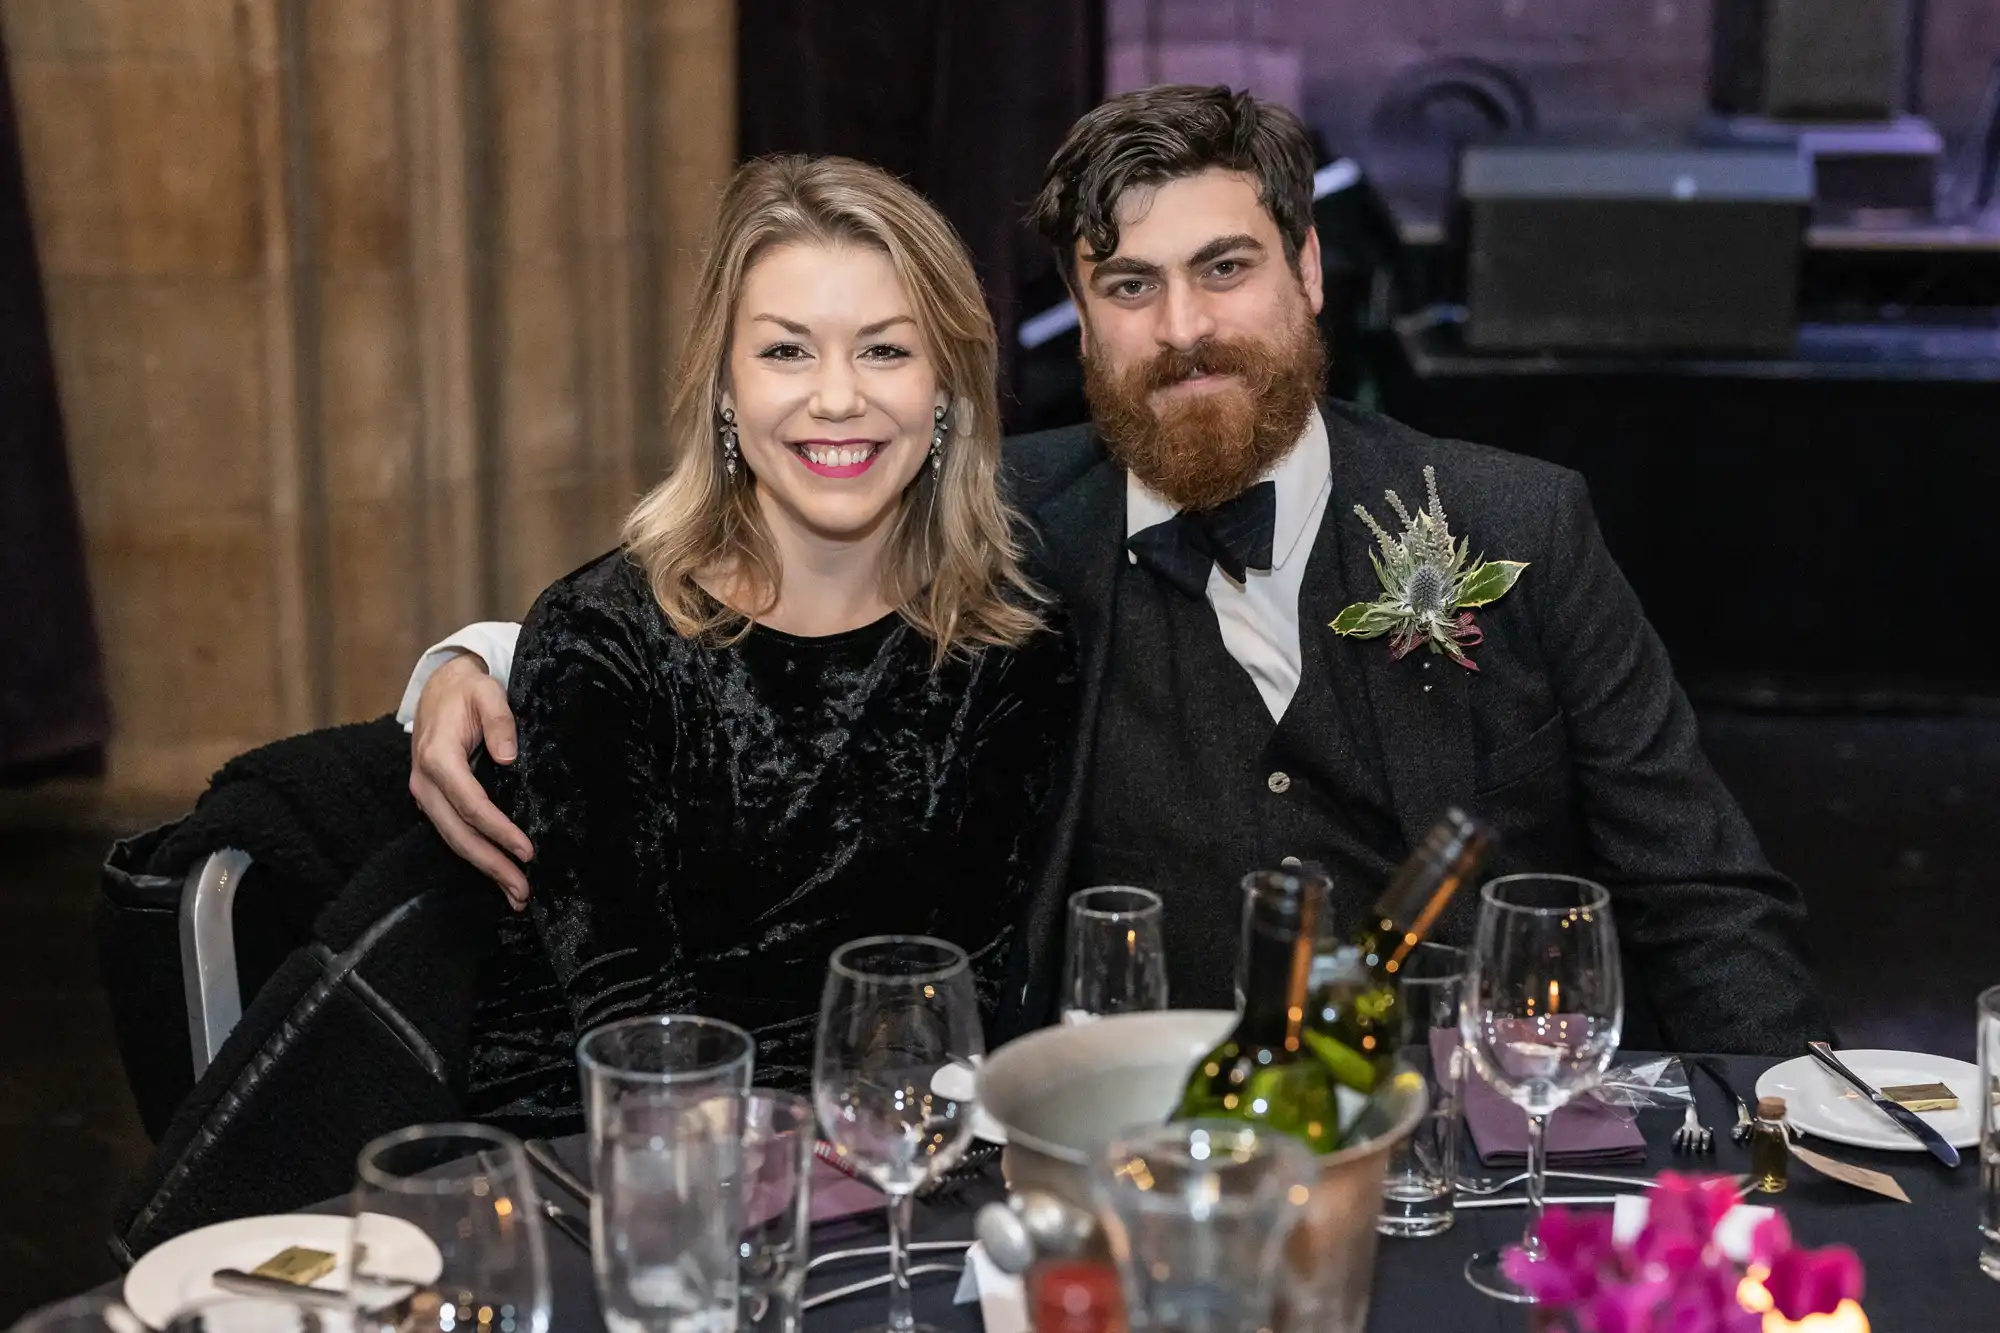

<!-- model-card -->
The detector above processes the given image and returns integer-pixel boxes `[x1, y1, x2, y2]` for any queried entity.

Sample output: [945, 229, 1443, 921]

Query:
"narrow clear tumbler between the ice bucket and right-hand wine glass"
[1376, 943, 1466, 1237]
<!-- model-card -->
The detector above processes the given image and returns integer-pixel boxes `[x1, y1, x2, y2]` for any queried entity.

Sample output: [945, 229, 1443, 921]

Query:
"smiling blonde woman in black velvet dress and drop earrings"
[470, 158, 1074, 1129]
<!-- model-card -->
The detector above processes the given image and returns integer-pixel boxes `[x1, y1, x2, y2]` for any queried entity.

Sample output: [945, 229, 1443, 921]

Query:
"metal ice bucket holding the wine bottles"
[980, 1009, 1426, 1333]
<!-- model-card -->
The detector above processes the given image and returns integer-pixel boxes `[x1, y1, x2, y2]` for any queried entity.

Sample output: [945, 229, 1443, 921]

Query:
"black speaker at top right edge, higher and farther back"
[1708, 0, 1910, 120]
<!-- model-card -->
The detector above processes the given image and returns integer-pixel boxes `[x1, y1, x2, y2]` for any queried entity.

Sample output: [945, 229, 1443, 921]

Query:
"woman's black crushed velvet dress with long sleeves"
[468, 552, 1076, 1133]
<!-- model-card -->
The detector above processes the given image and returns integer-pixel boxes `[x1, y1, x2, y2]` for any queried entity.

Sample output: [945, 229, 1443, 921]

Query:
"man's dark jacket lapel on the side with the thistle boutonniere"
[1300, 410, 1474, 847]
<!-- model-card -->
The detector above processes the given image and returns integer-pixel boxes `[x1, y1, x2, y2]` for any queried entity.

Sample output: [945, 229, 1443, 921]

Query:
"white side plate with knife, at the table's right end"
[1756, 1051, 1980, 1153]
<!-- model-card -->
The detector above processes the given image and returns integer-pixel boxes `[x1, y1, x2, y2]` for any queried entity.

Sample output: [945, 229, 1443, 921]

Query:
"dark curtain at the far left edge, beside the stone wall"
[0, 31, 110, 781]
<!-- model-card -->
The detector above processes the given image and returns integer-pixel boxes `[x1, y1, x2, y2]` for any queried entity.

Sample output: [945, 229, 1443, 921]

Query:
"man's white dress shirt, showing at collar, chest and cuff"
[396, 408, 1334, 731]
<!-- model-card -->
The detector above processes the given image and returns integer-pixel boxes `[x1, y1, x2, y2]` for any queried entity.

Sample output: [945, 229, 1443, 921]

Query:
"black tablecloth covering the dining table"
[90, 1057, 2000, 1333]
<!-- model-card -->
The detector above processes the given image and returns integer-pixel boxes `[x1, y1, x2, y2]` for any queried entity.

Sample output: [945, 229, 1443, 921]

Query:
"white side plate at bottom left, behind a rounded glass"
[124, 1213, 444, 1329]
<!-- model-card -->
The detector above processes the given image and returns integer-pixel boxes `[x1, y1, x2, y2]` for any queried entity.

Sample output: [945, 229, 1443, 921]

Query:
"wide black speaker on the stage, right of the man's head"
[1452, 144, 1812, 354]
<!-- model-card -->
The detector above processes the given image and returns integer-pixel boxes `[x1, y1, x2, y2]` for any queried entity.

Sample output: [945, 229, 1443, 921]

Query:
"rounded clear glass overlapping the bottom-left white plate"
[348, 1125, 548, 1333]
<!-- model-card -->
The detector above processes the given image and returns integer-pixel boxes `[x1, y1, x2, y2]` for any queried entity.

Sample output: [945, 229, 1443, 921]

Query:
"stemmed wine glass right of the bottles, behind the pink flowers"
[1458, 875, 1624, 1305]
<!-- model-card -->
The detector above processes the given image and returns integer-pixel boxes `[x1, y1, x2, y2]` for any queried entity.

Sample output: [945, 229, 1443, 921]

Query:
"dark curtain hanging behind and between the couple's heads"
[736, 0, 1104, 424]
